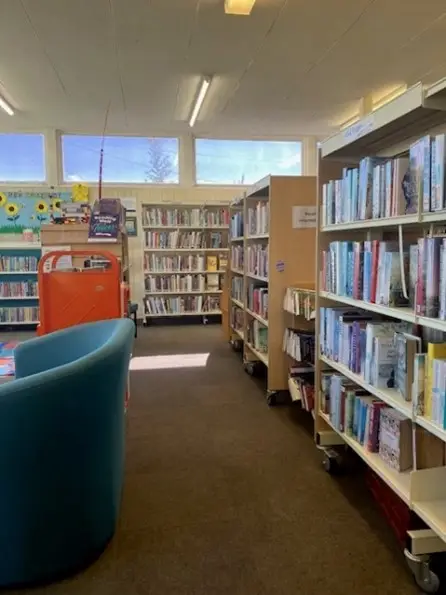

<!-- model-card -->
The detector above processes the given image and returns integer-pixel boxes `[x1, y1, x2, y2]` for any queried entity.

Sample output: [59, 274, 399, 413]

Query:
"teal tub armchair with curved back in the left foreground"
[0, 318, 134, 587]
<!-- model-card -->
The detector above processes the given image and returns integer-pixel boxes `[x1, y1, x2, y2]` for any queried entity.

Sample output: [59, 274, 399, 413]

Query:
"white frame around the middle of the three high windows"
[57, 130, 184, 190]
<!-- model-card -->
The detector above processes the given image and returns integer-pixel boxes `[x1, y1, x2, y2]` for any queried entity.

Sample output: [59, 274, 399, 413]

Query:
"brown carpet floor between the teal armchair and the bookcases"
[8, 326, 417, 595]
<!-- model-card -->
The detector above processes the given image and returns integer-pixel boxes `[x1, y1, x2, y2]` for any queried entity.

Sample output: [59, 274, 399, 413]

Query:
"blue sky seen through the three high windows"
[0, 134, 301, 184]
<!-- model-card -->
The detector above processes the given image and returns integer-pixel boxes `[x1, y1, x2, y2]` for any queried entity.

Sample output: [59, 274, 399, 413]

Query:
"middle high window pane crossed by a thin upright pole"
[62, 135, 178, 184]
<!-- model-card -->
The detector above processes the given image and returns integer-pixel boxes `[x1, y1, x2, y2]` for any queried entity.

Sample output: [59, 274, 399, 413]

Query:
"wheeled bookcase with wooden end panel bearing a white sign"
[229, 176, 316, 405]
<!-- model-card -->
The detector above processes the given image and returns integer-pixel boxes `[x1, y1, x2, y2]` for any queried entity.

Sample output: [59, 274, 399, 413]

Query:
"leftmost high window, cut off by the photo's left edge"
[0, 134, 46, 182]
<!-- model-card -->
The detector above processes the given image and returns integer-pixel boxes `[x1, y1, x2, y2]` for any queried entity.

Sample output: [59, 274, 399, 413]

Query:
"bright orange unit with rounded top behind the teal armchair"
[37, 250, 122, 335]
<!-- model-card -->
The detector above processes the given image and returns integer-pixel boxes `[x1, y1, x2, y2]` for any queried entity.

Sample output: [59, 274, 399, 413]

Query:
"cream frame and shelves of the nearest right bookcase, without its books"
[315, 79, 446, 592]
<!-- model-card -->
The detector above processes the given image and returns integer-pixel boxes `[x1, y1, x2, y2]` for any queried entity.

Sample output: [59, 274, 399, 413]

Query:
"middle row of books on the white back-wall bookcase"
[144, 252, 228, 273]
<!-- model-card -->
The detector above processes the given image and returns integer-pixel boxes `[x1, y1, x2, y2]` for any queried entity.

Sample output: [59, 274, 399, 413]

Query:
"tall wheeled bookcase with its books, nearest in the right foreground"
[315, 79, 446, 592]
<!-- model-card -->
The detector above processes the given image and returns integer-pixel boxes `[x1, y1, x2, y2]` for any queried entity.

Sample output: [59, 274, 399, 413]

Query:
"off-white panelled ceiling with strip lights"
[0, 0, 446, 137]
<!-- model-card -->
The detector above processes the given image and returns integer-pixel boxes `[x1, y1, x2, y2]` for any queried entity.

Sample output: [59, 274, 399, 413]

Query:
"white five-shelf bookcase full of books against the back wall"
[142, 203, 229, 324]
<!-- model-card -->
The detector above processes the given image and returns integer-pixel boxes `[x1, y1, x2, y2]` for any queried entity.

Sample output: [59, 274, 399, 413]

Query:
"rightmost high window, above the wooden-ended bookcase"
[195, 138, 302, 185]
